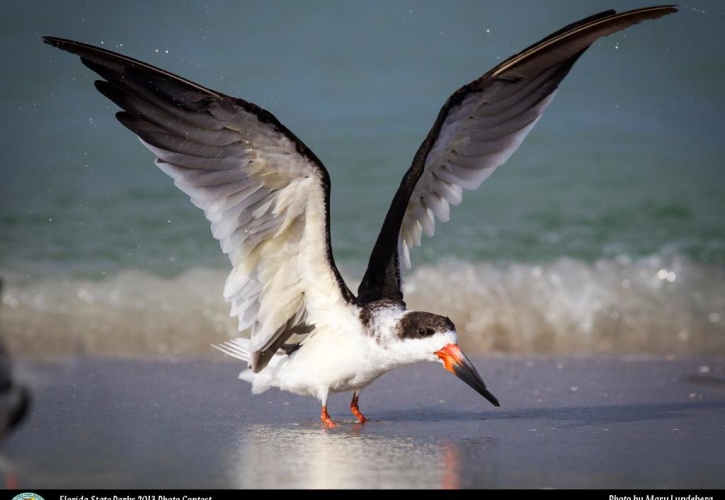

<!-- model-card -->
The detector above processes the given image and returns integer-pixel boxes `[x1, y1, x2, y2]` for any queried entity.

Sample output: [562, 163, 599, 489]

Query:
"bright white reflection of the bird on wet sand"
[231, 422, 493, 488]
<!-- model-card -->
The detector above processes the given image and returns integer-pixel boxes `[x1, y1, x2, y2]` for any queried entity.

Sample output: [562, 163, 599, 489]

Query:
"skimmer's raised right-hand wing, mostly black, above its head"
[358, 6, 677, 302]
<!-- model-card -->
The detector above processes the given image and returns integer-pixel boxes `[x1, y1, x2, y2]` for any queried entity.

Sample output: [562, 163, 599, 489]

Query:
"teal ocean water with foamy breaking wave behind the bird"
[0, 1, 725, 355]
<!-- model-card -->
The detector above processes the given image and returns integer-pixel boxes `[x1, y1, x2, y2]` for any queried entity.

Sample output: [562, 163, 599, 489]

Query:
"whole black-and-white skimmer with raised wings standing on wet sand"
[44, 6, 676, 427]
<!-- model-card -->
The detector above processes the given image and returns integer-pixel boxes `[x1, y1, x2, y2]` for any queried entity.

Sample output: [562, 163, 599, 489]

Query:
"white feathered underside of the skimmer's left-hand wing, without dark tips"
[136, 101, 345, 352]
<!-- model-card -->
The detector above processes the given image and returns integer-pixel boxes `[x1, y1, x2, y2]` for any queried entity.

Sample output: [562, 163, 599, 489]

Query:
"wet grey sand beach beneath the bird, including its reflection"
[2, 356, 725, 489]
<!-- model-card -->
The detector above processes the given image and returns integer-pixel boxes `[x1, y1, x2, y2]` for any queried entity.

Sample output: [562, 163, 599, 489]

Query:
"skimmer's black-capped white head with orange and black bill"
[398, 311, 499, 406]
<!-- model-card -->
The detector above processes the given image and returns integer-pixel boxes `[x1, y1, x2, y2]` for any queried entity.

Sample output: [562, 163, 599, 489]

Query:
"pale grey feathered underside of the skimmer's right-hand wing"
[398, 66, 560, 269]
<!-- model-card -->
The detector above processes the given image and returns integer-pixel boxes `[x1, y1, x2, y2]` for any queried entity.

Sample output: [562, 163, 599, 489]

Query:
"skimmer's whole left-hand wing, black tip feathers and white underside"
[44, 37, 355, 371]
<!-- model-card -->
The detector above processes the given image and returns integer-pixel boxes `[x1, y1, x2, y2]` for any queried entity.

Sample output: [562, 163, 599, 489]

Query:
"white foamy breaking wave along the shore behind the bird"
[0, 256, 725, 357]
